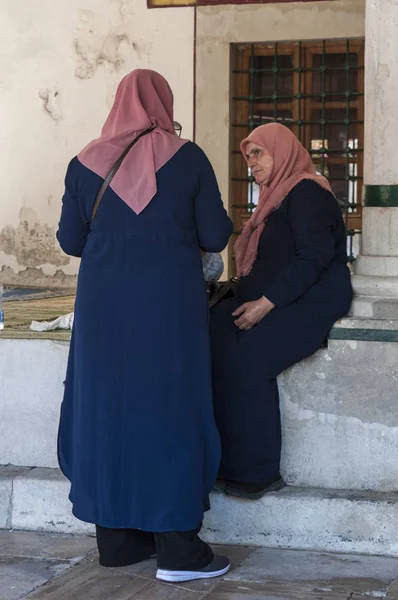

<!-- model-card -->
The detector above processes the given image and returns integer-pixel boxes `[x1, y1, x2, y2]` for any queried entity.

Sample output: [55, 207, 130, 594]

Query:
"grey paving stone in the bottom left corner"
[0, 557, 70, 600]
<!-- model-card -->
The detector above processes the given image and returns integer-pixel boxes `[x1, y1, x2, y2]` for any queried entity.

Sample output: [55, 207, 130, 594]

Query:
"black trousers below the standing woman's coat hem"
[96, 525, 214, 571]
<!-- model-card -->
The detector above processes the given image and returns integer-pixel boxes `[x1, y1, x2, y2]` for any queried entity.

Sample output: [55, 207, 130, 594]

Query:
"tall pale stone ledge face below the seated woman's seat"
[0, 338, 398, 492]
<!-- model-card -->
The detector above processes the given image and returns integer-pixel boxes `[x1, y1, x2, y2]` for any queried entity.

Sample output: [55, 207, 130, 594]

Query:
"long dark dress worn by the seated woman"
[211, 180, 352, 483]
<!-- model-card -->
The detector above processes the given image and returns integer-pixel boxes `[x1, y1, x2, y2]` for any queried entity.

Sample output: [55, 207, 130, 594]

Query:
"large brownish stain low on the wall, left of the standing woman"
[0, 207, 70, 267]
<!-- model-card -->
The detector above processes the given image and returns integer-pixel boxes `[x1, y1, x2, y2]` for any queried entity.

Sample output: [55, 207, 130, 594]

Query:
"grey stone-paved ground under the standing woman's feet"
[0, 531, 398, 600]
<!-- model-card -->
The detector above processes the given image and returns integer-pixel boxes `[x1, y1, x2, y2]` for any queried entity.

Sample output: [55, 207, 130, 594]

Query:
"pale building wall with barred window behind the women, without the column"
[0, 0, 366, 286]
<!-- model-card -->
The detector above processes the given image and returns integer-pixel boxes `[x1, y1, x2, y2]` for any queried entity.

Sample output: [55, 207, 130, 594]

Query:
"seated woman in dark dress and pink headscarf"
[211, 124, 352, 499]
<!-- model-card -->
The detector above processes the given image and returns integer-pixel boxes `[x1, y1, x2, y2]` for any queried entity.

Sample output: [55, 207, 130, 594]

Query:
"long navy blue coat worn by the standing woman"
[58, 143, 232, 532]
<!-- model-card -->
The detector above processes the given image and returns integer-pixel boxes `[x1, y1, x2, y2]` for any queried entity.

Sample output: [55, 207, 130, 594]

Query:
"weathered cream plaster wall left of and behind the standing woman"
[0, 0, 193, 285]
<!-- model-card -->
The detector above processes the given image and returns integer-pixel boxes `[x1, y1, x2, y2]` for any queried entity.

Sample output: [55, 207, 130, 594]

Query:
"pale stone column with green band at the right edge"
[353, 0, 398, 320]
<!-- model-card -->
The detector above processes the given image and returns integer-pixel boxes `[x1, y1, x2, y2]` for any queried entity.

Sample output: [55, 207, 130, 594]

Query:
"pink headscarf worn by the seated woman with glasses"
[235, 123, 333, 276]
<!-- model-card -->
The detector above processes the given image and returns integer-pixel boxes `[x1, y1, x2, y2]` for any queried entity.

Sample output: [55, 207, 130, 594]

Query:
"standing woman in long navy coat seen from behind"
[58, 70, 232, 581]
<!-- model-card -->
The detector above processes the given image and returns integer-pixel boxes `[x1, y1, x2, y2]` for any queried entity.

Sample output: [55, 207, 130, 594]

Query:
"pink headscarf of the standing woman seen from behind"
[78, 69, 188, 214]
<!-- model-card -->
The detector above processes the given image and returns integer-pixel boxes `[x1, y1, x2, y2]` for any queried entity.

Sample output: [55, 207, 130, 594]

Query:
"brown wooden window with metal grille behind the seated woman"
[231, 40, 364, 261]
